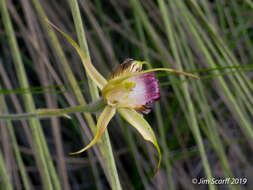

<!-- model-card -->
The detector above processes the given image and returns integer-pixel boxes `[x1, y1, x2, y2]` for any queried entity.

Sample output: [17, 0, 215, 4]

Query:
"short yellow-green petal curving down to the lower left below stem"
[70, 106, 116, 155]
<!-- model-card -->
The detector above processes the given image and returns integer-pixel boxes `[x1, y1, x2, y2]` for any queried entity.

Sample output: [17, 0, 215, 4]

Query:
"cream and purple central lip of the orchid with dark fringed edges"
[104, 59, 160, 114]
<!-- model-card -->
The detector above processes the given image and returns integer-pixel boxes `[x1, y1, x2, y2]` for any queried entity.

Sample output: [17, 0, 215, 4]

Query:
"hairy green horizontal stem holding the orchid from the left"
[0, 99, 105, 120]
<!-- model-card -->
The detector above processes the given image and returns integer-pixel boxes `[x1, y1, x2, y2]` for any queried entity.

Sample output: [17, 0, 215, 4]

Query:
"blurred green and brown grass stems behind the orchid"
[0, 0, 253, 190]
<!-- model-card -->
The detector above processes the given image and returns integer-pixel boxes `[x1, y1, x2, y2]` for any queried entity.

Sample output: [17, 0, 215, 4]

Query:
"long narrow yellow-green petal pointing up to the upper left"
[46, 20, 107, 89]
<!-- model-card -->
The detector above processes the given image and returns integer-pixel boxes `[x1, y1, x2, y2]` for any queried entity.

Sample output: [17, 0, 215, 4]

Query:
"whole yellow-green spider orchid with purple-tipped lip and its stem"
[0, 20, 199, 176]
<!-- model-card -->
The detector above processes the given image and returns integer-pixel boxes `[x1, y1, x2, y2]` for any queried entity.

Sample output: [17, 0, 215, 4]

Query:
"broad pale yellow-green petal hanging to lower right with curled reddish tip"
[118, 108, 162, 176]
